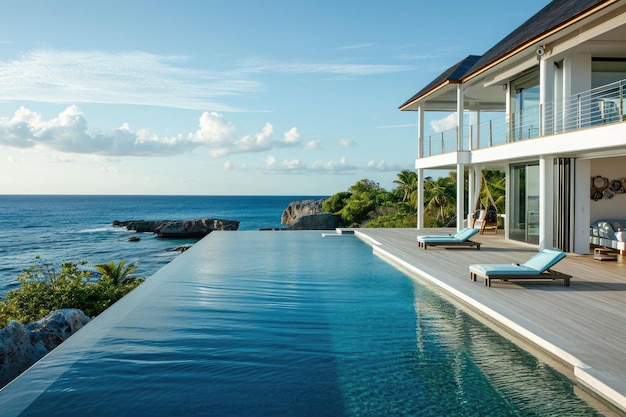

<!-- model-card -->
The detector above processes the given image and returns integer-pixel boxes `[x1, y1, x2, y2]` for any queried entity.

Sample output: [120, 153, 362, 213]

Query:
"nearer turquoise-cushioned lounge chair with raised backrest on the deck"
[469, 249, 571, 287]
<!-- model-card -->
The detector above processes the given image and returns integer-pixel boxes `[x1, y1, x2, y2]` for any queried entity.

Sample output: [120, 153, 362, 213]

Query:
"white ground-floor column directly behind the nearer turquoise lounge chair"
[539, 156, 554, 250]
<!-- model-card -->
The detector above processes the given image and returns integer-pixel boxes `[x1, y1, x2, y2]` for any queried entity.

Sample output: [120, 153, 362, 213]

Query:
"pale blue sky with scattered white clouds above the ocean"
[0, 0, 548, 195]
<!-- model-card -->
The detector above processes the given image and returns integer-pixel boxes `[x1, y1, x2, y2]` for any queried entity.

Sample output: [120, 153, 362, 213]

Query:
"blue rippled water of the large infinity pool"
[0, 231, 599, 417]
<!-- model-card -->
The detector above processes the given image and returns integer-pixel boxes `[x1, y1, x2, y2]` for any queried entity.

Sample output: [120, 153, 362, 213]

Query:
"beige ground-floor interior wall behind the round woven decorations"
[589, 156, 626, 222]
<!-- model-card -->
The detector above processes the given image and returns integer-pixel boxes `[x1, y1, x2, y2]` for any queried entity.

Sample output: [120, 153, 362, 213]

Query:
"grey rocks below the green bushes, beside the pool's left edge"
[0, 308, 89, 388]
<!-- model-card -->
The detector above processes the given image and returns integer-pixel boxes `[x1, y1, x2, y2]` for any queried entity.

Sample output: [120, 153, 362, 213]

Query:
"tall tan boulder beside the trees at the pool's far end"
[281, 199, 341, 230]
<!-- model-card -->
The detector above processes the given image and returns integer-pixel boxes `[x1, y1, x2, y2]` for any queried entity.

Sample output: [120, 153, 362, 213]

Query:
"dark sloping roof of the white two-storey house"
[400, 0, 612, 108]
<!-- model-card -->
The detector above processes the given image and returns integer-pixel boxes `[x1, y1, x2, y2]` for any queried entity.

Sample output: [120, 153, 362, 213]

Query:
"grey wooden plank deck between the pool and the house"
[354, 229, 626, 412]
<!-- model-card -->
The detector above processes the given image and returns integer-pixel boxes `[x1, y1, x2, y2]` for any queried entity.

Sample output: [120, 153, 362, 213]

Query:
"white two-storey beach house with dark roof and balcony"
[400, 0, 626, 253]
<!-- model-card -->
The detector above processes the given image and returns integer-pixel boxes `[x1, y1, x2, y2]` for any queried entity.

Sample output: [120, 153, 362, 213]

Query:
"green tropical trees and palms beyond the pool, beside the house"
[322, 170, 505, 227]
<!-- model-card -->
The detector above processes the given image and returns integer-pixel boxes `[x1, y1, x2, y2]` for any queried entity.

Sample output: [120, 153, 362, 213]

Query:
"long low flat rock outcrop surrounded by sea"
[113, 218, 239, 238]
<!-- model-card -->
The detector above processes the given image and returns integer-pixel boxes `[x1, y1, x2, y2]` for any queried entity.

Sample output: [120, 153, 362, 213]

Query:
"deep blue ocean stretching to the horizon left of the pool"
[0, 195, 324, 296]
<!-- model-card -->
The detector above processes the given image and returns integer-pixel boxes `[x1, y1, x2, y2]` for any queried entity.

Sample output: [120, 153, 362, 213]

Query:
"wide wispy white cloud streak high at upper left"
[0, 49, 264, 111]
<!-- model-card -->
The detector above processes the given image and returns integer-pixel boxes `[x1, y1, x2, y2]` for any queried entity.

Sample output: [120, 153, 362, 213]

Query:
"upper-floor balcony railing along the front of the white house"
[422, 80, 626, 158]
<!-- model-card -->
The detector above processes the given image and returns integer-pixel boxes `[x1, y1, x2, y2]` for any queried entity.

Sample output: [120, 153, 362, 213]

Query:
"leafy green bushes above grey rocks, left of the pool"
[0, 259, 143, 327]
